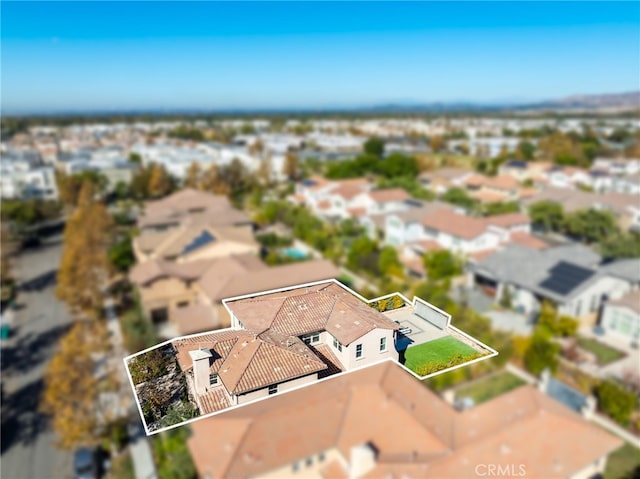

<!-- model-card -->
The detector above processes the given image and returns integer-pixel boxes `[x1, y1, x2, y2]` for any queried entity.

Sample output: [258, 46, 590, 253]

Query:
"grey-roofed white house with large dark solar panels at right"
[469, 244, 640, 325]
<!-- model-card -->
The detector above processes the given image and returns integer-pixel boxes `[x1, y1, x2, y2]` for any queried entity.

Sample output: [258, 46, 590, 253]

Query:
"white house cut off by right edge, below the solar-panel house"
[599, 290, 640, 344]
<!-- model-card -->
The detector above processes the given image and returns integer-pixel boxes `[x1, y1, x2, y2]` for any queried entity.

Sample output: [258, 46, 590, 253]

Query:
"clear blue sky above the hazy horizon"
[0, 0, 640, 113]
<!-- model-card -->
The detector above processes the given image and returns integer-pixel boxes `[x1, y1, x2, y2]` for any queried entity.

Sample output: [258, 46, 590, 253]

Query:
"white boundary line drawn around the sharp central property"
[122, 279, 499, 436]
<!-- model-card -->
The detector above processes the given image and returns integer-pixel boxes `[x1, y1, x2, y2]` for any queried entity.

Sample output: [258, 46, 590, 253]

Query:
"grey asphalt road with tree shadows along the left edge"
[0, 237, 73, 479]
